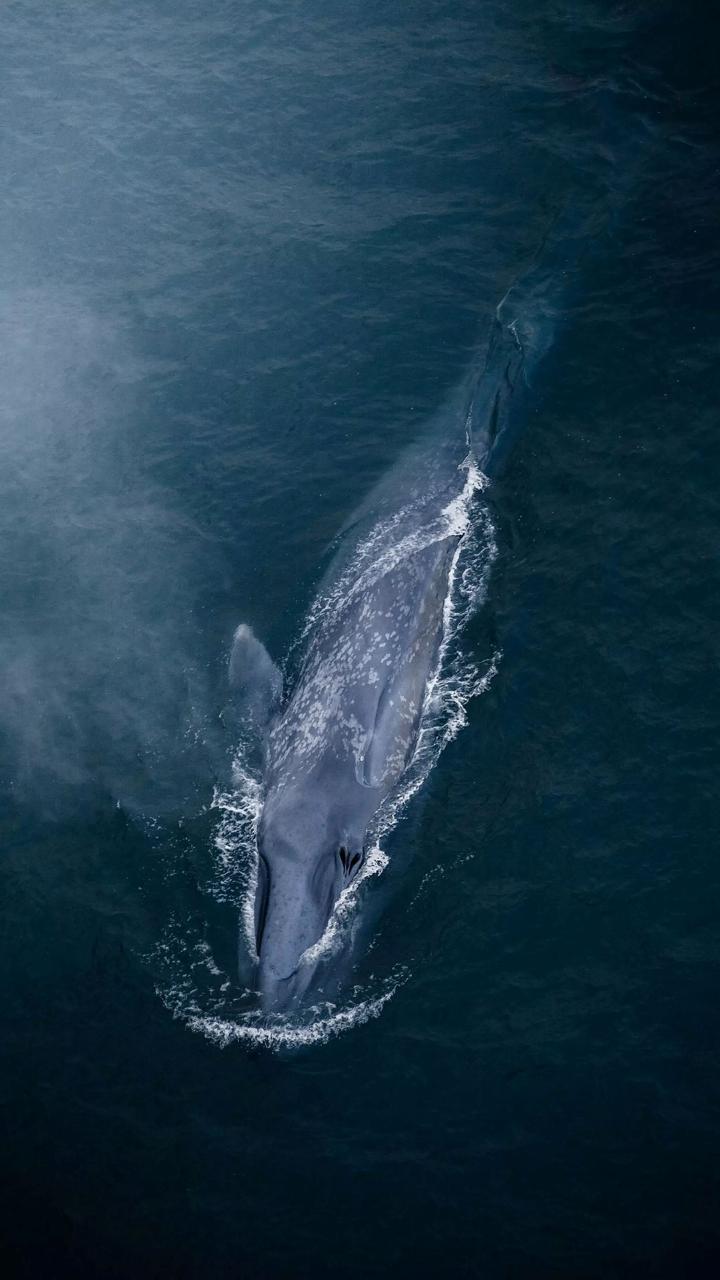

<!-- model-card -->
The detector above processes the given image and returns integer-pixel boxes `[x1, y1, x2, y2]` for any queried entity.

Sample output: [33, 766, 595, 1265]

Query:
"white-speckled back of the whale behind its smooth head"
[266, 450, 468, 820]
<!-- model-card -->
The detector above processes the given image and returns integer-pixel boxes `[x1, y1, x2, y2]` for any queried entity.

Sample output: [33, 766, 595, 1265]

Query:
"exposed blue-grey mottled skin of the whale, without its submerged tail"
[232, 465, 469, 1011]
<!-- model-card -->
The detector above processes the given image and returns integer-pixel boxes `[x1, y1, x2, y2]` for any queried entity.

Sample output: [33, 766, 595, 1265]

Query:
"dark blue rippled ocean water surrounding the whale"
[0, 0, 720, 1280]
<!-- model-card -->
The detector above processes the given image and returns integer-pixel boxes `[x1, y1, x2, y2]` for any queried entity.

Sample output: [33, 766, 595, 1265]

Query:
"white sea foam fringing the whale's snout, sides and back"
[151, 457, 501, 1050]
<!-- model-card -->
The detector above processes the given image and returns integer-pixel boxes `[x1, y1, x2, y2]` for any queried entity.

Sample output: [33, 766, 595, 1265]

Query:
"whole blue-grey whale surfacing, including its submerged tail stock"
[229, 294, 540, 1014]
